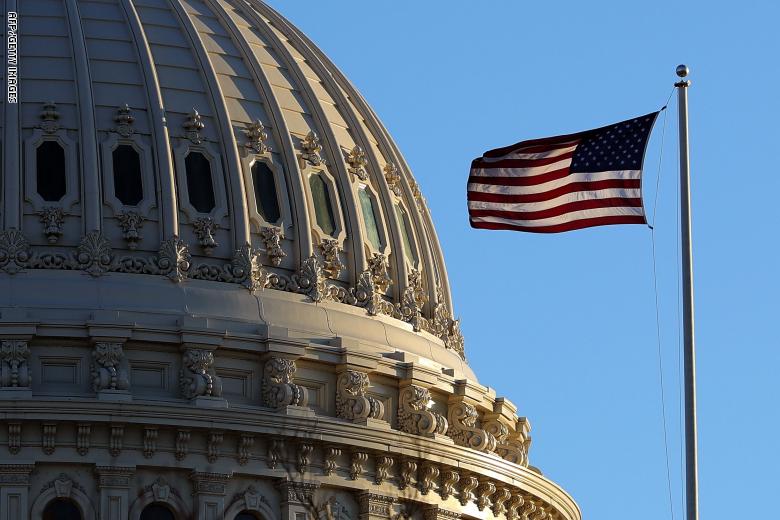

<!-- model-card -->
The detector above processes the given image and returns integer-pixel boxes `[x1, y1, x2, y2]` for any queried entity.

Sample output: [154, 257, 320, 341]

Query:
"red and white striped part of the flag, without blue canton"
[468, 134, 646, 233]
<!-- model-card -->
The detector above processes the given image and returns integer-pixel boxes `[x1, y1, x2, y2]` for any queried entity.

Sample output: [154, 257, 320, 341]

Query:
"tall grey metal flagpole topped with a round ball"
[674, 65, 699, 520]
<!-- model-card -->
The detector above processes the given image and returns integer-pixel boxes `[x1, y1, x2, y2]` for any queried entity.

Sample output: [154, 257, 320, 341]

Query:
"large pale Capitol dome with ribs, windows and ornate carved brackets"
[0, 0, 580, 520]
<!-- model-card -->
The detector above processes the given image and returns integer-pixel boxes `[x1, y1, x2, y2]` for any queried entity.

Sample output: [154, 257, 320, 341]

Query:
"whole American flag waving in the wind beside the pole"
[468, 112, 659, 233]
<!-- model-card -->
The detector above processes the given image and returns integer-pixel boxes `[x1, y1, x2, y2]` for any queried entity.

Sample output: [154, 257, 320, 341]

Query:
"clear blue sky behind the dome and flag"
[271, 0, 780, 520]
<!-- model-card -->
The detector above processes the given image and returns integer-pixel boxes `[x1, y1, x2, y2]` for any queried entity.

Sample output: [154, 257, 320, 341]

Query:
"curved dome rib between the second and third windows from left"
[120, 0, 179, 241]
